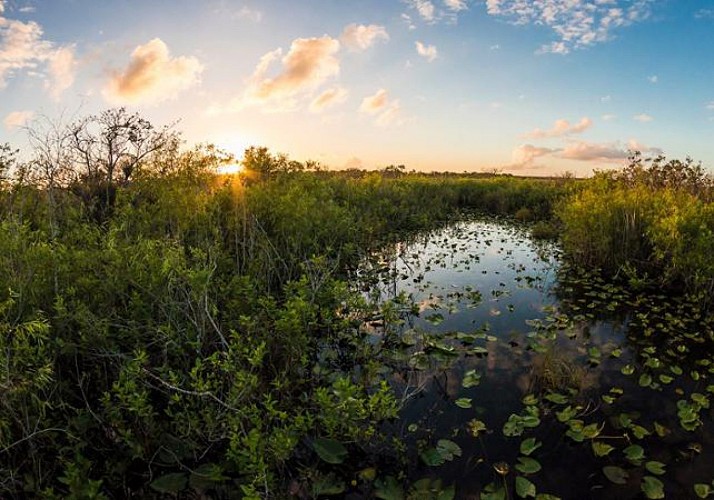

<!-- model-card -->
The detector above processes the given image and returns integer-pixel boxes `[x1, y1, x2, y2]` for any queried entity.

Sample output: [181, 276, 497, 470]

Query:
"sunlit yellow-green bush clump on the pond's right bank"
[556, 155, 714, 301]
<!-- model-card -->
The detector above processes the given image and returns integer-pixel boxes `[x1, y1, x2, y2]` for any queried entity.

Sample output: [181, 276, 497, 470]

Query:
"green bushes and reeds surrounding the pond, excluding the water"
[0, 109, 714, 498]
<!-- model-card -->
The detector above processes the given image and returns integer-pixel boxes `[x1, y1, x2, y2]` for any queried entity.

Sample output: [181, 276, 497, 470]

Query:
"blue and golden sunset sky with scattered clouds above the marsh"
[0, 0, 714, 176]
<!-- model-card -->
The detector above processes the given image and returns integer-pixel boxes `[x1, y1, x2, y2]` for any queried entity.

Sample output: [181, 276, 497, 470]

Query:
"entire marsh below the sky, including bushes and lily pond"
[0, 110, 714, 500]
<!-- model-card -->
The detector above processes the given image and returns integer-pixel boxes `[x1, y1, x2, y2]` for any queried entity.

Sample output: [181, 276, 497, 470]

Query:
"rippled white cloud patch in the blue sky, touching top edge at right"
[486, 0, 653, 54]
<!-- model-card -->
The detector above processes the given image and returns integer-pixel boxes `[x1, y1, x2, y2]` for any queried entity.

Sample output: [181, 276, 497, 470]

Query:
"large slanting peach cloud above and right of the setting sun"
[214, 35, 340, 112]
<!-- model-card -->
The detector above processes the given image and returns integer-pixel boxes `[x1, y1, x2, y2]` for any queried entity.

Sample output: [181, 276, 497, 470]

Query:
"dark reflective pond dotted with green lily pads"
[356, 219, 714, 499]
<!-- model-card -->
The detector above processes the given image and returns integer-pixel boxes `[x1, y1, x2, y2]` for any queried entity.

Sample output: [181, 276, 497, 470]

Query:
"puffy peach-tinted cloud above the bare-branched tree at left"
[102, 38, 203, 104]
